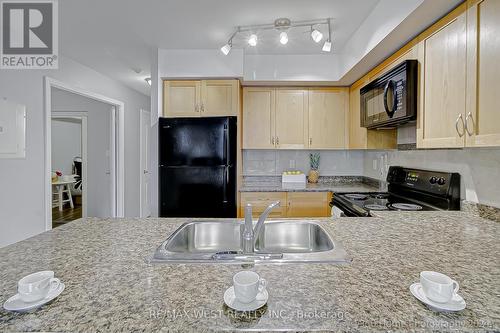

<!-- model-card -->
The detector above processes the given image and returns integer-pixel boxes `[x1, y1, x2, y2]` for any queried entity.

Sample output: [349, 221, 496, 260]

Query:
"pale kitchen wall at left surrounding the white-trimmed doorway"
[0, 56, 150, 246]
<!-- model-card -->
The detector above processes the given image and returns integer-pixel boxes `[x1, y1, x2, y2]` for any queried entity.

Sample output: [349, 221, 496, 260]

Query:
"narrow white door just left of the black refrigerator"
[140, 110, 151, 217]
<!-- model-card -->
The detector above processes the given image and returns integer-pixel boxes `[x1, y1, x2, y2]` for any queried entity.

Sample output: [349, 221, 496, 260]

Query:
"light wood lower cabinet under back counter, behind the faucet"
[240, 192, 332, 218]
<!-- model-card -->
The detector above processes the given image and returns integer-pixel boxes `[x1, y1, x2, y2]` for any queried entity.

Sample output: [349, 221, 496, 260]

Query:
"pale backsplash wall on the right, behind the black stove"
[364, 148, 500, 207]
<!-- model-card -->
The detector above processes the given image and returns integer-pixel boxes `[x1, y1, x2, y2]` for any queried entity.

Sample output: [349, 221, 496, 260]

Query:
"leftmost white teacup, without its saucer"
[17, 271, 61, 303]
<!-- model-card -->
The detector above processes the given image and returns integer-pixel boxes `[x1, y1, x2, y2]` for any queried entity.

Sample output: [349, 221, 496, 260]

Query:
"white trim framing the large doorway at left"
[44, 76, 125, 230]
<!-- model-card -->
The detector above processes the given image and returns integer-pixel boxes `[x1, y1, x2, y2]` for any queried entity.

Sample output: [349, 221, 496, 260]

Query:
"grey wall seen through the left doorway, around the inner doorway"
[51, 88, 113, 217]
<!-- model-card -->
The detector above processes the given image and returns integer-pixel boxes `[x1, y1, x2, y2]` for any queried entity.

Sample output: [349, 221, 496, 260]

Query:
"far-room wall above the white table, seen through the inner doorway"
[51, 118, 82, 175]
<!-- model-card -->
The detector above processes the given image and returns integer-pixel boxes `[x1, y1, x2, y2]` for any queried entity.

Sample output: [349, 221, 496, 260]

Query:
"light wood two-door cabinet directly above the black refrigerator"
[163, 80, 239, 117]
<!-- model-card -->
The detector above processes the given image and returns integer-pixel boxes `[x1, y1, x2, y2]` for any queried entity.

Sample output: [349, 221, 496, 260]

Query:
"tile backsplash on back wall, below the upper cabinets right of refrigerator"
[243, 150, 364, 176]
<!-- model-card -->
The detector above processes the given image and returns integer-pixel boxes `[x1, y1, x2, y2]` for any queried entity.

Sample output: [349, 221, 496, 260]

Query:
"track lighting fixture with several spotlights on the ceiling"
[220, 18, 332, 55]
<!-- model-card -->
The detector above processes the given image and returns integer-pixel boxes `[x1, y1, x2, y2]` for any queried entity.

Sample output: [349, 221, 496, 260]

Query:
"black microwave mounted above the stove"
[360, 60, 418, 128]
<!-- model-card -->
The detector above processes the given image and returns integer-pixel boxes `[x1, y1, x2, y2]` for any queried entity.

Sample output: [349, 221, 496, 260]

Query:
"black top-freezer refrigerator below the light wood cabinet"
[158, 117, 237, 217]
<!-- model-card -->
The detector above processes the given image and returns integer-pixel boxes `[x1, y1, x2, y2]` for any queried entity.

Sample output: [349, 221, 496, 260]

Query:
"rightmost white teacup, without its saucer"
[420, 271, 459, 303]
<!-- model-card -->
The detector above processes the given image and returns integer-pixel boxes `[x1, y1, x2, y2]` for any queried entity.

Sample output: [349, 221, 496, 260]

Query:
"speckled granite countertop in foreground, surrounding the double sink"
[0, 212, 500, 332]
